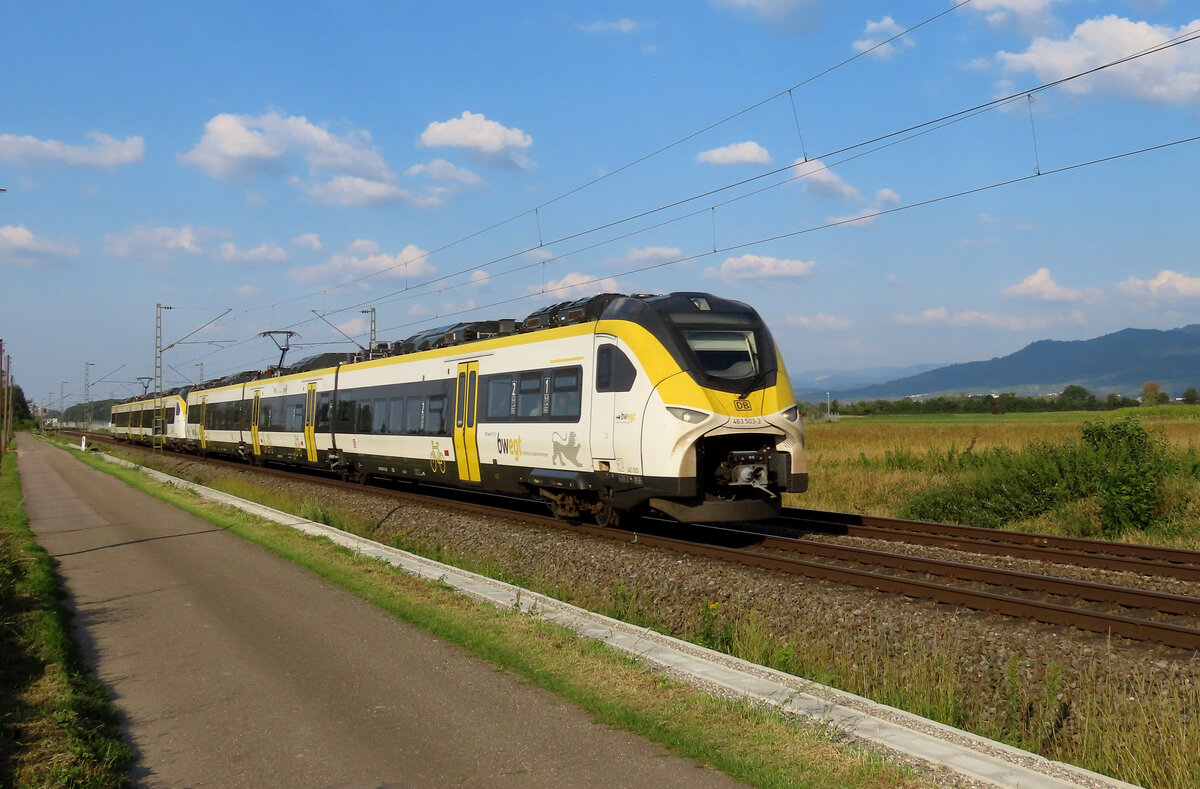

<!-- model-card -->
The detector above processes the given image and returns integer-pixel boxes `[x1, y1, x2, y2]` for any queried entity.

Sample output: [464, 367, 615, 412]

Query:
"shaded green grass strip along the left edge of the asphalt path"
[0, 453, 133, 789]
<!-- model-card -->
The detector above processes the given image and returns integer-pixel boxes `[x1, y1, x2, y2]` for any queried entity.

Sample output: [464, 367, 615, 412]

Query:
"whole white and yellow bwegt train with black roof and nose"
[112, 293, 808, 524]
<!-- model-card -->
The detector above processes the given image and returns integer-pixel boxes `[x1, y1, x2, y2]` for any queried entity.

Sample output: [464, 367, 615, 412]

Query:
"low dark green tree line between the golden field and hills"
[800, 381, 1200, 416]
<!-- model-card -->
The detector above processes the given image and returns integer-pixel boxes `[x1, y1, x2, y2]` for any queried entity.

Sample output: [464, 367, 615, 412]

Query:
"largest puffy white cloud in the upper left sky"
[176, 112, 394, 182]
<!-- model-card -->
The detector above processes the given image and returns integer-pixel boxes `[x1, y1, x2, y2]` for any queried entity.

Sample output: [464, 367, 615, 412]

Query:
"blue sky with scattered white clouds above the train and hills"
[0, 0, 1200, 404]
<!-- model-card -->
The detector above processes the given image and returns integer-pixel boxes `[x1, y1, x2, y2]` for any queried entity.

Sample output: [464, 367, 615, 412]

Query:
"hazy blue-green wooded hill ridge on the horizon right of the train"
[797, 324, 1200, 402]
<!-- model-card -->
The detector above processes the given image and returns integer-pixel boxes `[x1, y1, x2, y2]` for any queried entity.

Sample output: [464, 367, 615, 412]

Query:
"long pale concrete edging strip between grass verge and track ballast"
[101, 453, 1136, 789]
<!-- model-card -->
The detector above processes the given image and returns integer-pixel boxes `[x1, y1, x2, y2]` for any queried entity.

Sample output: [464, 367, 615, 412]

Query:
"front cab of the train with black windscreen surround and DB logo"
[593, 293, 808, 522]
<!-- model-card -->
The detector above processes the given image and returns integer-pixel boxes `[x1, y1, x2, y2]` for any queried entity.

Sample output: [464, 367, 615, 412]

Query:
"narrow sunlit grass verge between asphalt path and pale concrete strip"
[44, 441, 924, 789]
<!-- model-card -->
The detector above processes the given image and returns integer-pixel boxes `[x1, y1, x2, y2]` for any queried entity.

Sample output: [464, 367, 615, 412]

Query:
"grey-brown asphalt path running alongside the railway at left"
[18, 435, 740, 789]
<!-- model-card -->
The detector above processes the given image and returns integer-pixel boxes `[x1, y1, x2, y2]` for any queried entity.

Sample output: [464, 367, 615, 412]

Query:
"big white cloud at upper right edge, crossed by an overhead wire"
[996, 14, 1200, 107]
